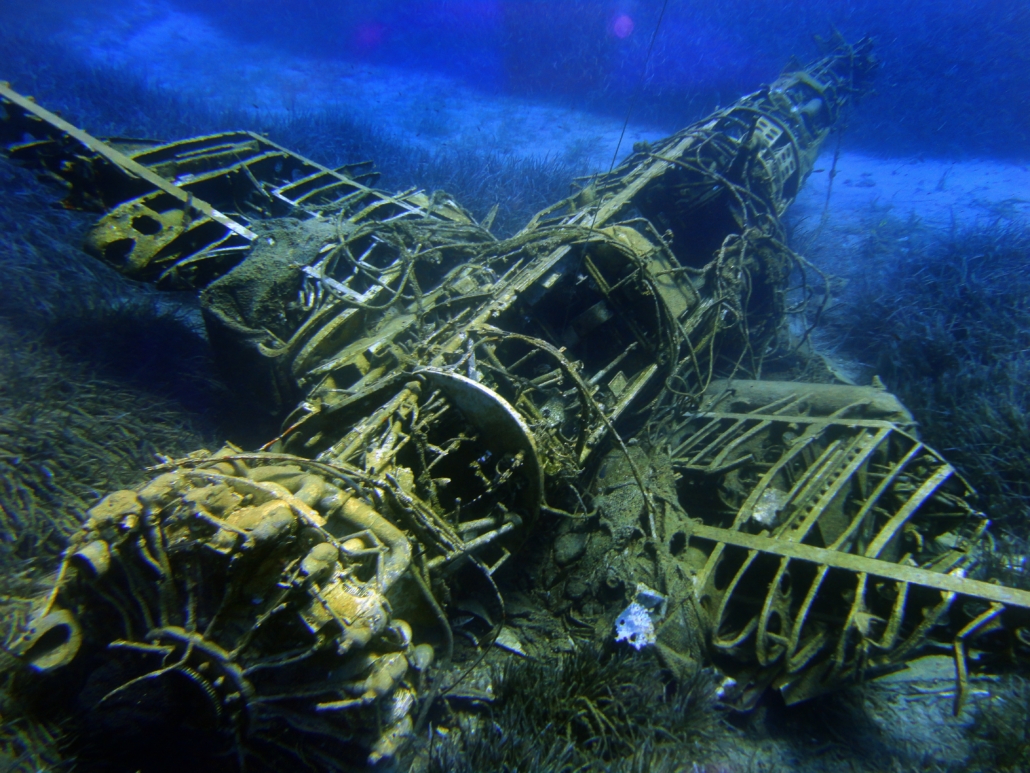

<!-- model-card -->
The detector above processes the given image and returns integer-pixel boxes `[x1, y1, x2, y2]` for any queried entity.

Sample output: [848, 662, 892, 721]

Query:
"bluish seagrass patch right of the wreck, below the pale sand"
[797, 207, 1030, 564]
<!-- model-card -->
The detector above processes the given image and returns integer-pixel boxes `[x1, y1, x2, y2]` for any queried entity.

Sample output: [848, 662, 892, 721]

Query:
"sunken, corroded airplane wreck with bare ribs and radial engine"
[0, 41, 1030, 767]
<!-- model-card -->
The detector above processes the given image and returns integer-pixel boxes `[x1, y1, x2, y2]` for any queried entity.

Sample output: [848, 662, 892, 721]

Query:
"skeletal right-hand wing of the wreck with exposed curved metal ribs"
[667, 381, 1030, 706]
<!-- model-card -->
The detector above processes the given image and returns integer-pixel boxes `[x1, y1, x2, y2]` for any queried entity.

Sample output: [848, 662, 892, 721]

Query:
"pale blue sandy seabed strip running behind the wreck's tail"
[58, 0, 1030, 245]
